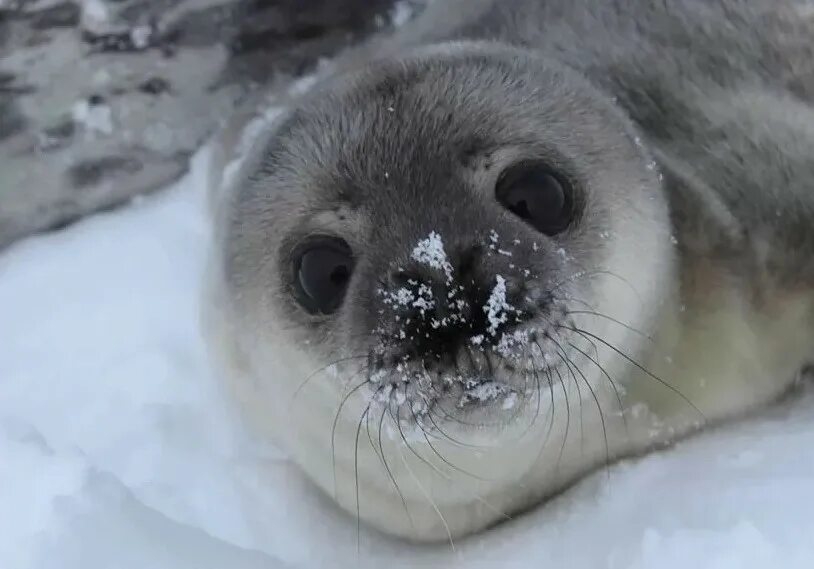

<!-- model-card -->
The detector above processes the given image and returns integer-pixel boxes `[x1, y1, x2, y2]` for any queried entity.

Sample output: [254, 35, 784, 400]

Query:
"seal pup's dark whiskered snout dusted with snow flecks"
[372, 232, 548, 418]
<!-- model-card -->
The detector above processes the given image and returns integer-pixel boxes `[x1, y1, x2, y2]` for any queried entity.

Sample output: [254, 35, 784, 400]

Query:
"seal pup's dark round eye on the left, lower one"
[293, 236, 354, 314]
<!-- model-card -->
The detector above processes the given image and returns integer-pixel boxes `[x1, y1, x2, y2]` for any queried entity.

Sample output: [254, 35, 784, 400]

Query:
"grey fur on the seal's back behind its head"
[372, 0, 814, 283]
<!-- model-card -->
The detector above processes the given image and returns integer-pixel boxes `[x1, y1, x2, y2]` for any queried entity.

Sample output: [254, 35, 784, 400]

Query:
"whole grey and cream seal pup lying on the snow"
[204, 0, 814, 541]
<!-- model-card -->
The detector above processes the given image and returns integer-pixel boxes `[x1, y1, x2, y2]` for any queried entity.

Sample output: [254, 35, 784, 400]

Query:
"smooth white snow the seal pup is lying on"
[0, 148, 814, 569]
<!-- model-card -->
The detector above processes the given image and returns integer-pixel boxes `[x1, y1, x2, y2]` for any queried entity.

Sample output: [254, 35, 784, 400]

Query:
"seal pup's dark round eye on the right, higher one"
[495, 164, 573, 236]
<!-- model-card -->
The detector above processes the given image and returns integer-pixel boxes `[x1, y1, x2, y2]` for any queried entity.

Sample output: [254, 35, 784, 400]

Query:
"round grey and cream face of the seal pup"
[209, 44, 673, 539]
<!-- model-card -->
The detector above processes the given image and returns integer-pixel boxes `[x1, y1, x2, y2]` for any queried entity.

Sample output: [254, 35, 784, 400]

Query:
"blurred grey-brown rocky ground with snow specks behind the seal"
[0, 0, 411, 248]
